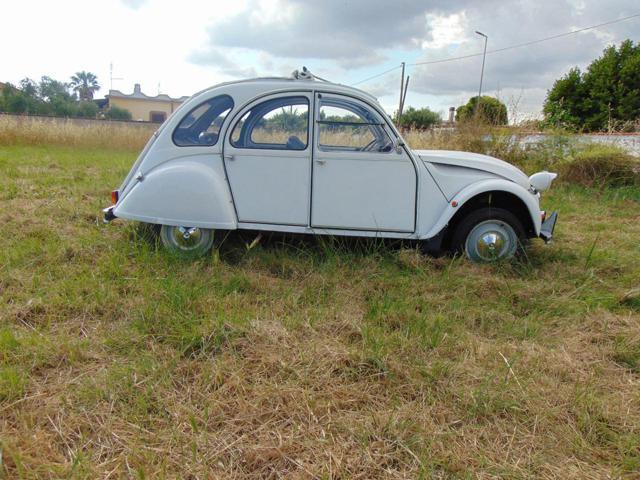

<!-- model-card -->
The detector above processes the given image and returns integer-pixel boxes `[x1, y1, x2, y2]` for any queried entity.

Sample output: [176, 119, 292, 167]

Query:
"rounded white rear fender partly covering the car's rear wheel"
[113, 155, 237, 230]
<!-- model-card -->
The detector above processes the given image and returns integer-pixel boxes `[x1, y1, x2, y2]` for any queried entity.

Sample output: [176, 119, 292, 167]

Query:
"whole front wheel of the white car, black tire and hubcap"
[451, 207, 525, 263]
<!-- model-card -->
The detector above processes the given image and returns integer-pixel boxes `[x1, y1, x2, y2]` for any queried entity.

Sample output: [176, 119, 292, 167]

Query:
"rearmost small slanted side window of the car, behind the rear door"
[173, 95, 233, 147]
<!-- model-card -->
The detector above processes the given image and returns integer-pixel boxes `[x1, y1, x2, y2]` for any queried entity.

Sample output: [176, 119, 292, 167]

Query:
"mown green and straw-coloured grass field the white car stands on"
[0, 123, 640, 479]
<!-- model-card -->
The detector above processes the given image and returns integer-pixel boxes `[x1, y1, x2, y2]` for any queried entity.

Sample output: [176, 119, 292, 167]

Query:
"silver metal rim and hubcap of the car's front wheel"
[465, 220, 518, 262]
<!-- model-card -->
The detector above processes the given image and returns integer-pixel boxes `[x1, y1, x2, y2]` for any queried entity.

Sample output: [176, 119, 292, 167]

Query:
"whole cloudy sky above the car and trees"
[0, 0, 640, 117]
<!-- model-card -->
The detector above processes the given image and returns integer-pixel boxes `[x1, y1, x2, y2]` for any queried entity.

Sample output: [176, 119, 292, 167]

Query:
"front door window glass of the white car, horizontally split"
[318, 97, 393, 152]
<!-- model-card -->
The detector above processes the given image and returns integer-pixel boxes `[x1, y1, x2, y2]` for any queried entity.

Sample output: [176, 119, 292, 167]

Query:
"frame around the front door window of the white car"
[314, 92, 396, 155]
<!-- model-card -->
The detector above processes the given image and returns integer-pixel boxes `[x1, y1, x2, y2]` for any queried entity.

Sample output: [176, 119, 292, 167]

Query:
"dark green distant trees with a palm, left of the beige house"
[0, 71, 131, 120]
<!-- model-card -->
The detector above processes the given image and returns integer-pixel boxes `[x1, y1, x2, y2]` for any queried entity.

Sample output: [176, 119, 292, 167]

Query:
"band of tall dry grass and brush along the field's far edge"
[0, 115, 640, 187]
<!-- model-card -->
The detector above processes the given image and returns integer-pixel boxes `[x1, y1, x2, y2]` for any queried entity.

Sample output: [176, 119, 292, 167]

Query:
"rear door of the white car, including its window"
[224, 93, 313, 226]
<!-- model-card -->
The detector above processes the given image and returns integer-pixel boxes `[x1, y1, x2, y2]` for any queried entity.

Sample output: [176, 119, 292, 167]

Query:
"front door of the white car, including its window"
[311, 93, 417, 232]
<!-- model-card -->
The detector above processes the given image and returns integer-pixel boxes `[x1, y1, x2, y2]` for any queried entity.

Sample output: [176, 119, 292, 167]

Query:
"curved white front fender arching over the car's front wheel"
[422, 178, 542, 238]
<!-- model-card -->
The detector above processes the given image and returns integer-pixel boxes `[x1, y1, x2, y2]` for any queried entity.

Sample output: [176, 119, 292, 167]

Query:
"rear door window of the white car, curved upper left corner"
[231, 97, 309, 150]
